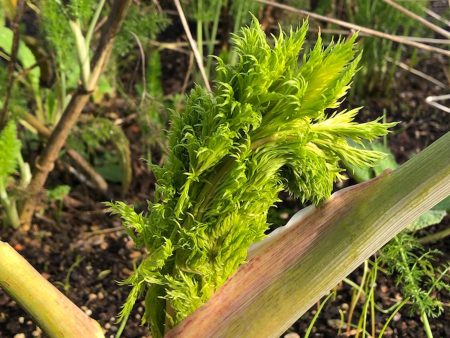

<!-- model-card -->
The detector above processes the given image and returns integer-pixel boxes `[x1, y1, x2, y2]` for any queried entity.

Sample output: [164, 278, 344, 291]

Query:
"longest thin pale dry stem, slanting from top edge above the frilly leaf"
[257, 0, 450, 56]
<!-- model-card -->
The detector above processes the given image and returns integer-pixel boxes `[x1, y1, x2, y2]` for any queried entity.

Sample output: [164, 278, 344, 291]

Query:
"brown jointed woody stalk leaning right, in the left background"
[20, 0, 131, 226]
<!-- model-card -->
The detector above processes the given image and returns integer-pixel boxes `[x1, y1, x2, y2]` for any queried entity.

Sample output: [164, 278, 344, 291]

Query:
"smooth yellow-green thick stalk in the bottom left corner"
[0, 241, 104, 338]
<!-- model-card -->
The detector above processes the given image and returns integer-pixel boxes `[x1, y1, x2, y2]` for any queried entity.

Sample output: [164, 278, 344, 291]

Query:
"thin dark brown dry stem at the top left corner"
[0, 0, 25, 131]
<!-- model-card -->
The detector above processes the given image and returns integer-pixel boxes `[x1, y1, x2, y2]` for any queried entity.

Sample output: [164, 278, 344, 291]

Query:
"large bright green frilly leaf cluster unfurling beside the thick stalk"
[109, 19, 391, 337]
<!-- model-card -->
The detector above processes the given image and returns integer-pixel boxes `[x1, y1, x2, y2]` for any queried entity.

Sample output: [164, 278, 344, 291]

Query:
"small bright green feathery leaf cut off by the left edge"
[0, 120, 21, 189]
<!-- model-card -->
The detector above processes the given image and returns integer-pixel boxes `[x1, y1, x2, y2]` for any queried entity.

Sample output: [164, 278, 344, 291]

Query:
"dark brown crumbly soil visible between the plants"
[0, 3, 450, 338]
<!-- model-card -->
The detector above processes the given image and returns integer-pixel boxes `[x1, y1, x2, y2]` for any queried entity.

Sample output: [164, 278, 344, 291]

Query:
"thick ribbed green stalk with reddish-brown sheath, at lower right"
[167, 133, 450, 338]
